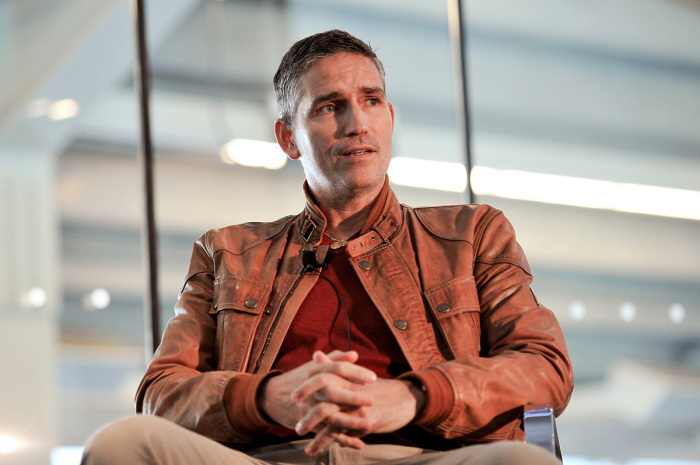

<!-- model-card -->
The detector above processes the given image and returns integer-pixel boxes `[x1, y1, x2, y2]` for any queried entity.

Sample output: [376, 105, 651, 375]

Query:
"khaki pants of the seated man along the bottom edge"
[81, 415, 561, 465]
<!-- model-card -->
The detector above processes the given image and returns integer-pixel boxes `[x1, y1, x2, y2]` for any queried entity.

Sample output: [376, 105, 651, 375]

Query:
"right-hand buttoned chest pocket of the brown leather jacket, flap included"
[424, 276, 481, 358]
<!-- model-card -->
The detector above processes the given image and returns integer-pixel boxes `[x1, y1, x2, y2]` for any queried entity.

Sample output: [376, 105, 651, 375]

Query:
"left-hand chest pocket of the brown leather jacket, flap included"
[209, 276, 271, 371]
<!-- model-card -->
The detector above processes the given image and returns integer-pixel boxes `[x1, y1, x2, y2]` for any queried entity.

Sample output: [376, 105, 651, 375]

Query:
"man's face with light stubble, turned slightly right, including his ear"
[275, 53, 394, 201]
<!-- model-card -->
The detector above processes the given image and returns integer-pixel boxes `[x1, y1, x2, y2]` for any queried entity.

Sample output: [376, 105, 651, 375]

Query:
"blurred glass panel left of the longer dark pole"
[0, 0, 144, 464]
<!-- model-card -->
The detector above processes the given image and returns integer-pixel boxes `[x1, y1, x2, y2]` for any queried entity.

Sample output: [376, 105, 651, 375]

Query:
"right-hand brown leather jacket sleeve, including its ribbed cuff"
[404, 210, 573, 442]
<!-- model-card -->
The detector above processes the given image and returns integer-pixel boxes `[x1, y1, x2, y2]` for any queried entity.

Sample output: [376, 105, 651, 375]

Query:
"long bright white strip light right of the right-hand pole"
[471, 166, 700, 220]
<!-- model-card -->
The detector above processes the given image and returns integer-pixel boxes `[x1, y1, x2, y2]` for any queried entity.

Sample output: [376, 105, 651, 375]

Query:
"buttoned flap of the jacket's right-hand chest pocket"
[424, 276, 480, 320]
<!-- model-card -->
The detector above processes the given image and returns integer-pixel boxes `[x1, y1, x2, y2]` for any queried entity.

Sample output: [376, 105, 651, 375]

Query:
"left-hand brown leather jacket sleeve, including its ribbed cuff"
[136, 239, 272, 443]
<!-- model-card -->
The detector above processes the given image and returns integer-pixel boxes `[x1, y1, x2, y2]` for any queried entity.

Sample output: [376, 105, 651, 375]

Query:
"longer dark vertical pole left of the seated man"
[131, 0, 160, 360]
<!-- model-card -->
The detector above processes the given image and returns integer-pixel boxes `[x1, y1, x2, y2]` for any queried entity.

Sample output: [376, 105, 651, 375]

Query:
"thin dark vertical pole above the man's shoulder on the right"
[447, 0, 475, 203]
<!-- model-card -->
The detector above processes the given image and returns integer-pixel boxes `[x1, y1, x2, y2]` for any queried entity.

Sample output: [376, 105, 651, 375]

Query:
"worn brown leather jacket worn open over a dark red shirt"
[136, 187, 573, 447]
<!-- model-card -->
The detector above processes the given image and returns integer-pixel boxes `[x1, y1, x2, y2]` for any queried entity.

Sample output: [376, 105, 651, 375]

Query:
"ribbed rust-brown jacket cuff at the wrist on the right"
[399, 368, 454, 427]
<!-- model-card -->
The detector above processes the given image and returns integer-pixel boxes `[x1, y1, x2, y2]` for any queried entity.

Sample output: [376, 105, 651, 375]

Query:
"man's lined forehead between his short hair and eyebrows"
[300, 53, 384, 99]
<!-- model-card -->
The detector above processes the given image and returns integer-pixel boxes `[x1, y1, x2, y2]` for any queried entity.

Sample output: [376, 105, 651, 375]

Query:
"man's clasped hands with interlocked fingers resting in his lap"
[258, 351, 425, 455]
